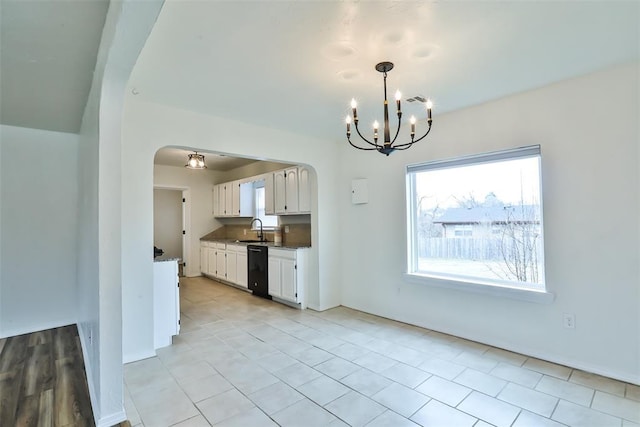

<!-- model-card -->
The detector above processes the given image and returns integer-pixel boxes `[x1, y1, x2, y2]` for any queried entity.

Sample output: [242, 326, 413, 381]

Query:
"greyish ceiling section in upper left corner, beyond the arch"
[0, 0, 109, 133]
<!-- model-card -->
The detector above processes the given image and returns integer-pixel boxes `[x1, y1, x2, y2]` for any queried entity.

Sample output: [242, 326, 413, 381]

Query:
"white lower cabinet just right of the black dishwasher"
[268, 248, 307, 308]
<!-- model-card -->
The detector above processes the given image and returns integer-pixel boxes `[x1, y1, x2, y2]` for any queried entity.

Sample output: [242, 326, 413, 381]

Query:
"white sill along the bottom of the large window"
[404, 273, 555, 304]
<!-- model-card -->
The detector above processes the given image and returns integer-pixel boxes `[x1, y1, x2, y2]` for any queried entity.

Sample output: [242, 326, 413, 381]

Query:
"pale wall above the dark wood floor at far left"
[0, 126, 78, 337]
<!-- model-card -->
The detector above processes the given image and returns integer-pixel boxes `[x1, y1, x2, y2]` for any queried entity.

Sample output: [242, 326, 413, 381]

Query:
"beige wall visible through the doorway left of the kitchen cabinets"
[153, 188, 183, 259]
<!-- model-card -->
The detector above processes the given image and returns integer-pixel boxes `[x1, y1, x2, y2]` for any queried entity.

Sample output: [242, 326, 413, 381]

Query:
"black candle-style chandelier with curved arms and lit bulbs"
[346, 62, 433, 156]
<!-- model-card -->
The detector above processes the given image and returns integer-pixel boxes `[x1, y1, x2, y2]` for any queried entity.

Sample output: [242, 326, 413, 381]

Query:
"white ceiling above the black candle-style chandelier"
[130, 1, 640, 141]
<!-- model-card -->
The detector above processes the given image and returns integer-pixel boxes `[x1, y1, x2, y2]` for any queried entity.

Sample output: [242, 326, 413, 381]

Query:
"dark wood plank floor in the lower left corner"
[0, 325, 95, 427]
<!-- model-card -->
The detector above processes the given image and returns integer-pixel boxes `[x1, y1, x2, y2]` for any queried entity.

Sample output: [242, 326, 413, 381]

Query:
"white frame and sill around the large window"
[404, 145, 555, 303]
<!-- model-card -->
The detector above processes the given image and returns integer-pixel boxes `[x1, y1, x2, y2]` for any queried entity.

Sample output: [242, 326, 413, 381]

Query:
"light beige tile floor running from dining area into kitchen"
[125, 278, 640, 427]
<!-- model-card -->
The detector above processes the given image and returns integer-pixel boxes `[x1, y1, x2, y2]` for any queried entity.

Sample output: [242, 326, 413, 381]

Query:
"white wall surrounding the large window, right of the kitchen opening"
[336, 64, 640, 383]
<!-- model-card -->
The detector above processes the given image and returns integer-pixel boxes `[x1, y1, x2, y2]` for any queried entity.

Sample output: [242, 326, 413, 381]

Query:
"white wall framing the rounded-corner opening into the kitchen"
[122, 96, 340, 359]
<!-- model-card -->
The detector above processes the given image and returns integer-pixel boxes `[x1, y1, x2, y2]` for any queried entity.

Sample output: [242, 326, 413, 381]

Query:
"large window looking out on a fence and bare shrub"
[407, 146, 545, 290]
